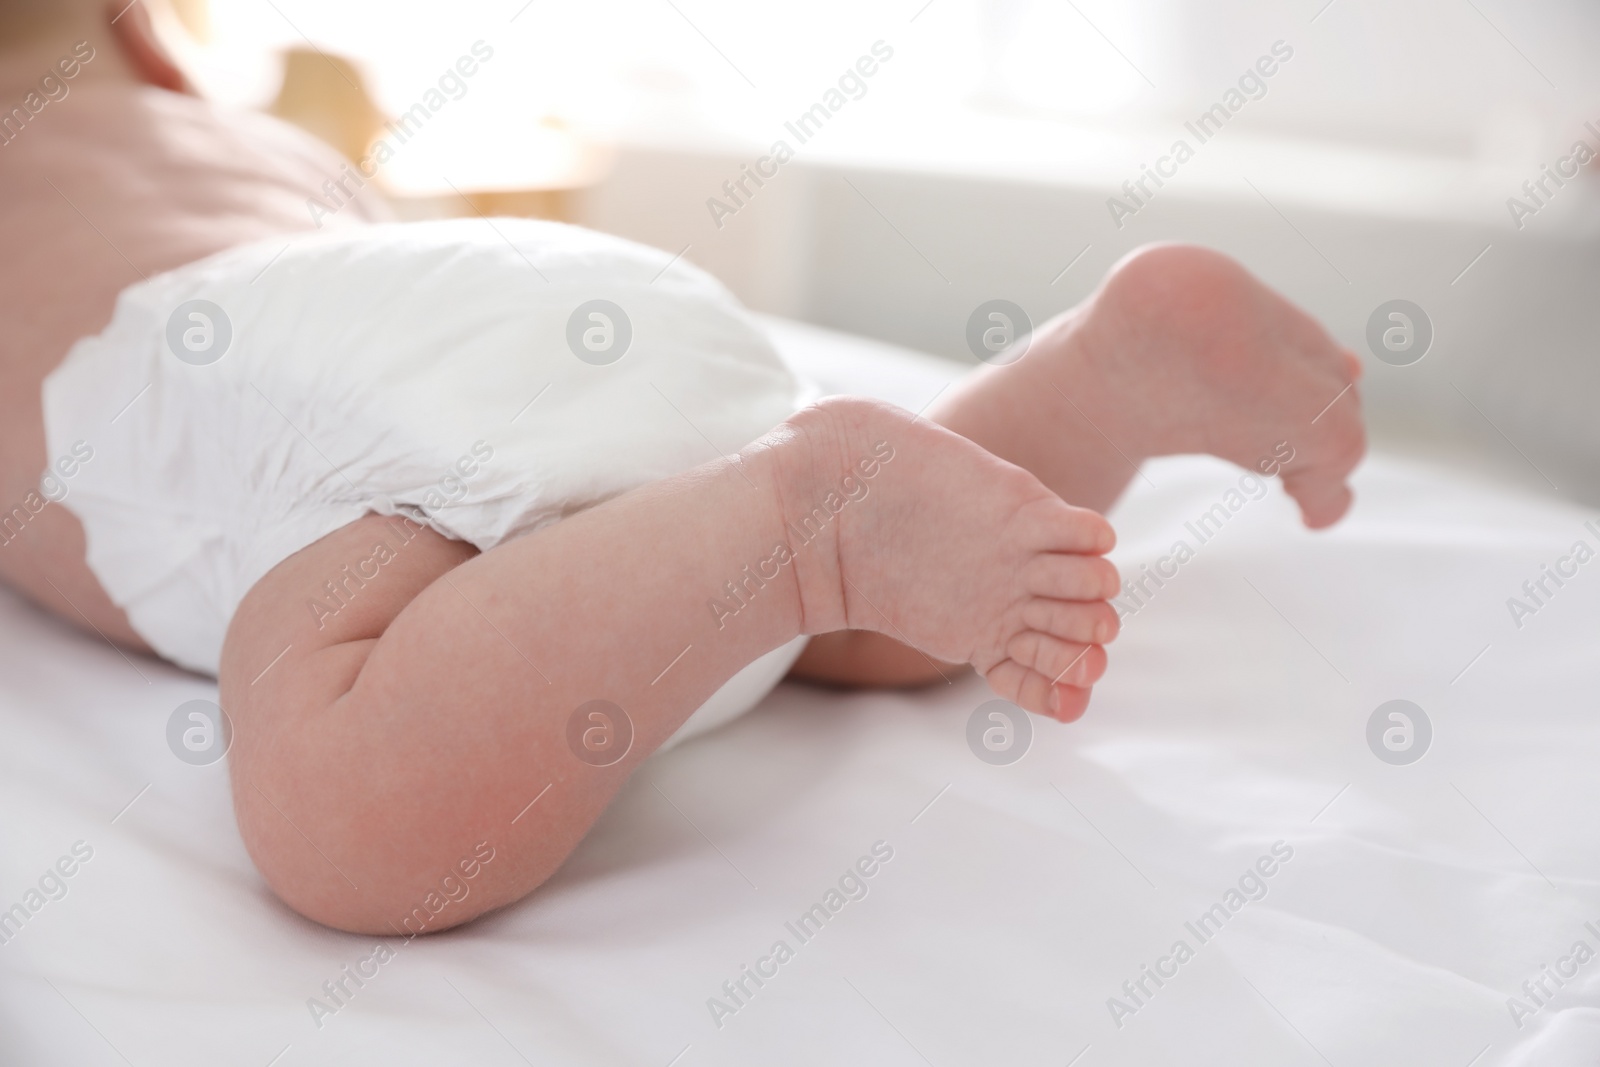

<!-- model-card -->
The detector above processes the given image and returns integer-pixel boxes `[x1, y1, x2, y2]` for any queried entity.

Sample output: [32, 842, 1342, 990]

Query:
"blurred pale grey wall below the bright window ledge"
[578, 147, 1600, 502]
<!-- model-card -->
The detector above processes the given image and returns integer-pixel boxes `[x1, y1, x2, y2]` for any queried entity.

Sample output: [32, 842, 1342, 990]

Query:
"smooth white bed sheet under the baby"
[0, 323, 1600, 1067]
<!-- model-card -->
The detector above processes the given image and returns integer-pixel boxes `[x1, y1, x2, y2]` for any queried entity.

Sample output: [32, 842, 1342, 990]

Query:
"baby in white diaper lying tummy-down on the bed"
[0, 0, 1363, 933]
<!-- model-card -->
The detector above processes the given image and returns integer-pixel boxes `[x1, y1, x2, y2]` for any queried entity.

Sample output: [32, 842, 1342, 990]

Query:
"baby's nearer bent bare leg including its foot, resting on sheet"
[221, 398, 1117, 933]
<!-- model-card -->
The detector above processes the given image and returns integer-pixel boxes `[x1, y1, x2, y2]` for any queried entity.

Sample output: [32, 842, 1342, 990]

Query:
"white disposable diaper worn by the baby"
[43, 219, 805, 739]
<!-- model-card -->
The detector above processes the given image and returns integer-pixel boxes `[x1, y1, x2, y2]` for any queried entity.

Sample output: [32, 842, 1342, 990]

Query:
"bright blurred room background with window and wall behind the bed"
[152, 0, 1600, 502]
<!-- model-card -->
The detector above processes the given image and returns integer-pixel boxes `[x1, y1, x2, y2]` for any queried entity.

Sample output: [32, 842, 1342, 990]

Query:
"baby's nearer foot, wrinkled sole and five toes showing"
[782, 397, 1118, 721]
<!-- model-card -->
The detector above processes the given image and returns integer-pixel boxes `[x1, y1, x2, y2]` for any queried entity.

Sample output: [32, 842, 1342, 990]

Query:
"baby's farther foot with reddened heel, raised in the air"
[1075, 245, 1366, 528]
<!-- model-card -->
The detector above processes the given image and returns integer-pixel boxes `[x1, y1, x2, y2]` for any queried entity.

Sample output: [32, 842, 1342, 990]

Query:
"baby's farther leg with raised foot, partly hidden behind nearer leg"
[794, 245, 1365, 685]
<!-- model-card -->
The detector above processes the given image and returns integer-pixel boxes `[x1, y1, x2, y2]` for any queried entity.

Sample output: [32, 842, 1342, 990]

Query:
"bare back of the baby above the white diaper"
[0, 82, 378, 645]
